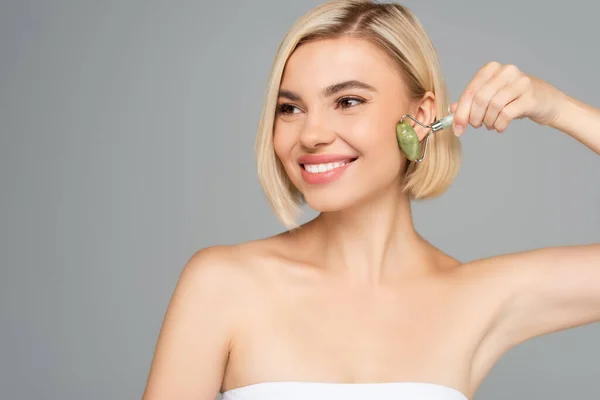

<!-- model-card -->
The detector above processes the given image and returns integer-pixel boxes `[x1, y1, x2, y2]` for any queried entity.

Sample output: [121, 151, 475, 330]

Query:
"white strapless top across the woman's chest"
[221, 382, 469, 400]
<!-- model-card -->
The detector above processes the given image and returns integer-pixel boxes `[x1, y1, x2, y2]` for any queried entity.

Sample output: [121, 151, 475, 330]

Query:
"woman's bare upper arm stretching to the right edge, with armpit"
[452, 244, 600, 390]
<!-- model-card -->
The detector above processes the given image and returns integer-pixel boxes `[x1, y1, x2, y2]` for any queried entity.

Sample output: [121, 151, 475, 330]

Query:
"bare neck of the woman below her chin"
[307, 183, 428, 286]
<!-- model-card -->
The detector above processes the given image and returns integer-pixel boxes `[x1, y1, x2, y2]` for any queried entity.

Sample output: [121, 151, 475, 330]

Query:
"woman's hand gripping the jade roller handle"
[450, 62, 565, 136]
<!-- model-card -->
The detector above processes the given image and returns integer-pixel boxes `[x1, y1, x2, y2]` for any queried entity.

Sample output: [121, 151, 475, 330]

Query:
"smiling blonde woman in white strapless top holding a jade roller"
[144, 1, 600, 400]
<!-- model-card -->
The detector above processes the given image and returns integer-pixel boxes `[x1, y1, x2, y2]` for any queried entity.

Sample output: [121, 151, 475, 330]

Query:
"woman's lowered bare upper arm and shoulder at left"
[143, 247, 235, 400]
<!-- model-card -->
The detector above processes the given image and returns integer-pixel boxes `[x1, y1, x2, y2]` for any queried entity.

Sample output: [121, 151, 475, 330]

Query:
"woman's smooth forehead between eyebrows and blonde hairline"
[281, 36, 401, 90]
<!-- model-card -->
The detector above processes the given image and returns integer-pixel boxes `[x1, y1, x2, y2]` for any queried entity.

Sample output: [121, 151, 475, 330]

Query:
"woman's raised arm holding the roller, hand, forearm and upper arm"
[451, 63, 600, 349]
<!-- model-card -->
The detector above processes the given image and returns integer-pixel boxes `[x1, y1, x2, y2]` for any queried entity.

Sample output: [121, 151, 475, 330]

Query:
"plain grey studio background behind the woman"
[0, 0, 600, 400]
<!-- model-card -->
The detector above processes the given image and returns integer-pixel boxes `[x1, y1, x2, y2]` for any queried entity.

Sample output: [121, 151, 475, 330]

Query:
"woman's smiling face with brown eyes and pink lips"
[274, 37, 433, 212]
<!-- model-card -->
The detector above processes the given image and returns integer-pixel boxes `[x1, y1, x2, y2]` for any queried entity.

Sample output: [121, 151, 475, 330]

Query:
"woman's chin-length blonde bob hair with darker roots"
[255, 0, 461, 229]
